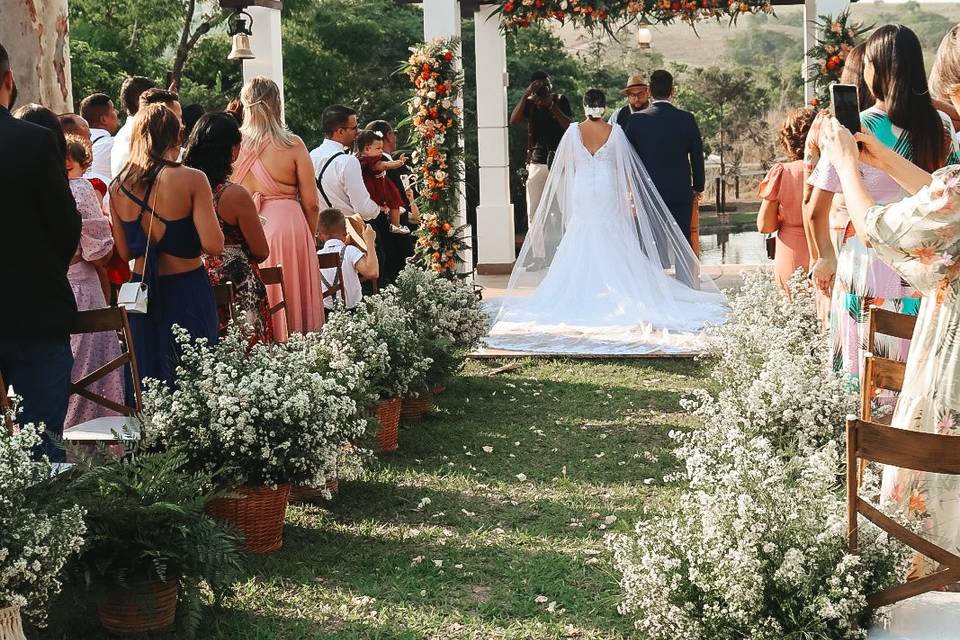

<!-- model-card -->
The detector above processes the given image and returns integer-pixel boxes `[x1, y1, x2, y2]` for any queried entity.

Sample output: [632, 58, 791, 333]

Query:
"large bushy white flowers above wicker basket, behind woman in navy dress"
[144, 331, 366, 486]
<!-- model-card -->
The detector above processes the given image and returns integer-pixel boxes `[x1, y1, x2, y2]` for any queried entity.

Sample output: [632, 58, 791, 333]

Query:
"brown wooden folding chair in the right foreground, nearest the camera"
[847, 418, 960, 608]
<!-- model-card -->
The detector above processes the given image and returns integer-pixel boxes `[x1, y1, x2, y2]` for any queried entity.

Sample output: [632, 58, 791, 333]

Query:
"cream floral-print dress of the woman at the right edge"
[866, 165, 960, 577]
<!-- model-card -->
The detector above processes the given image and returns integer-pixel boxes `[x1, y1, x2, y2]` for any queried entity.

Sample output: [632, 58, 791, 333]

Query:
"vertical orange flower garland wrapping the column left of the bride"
[405, 38, 467, 277]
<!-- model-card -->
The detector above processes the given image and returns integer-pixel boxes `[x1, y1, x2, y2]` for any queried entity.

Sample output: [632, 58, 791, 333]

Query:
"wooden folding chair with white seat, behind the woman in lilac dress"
[63, 307, 143, 444]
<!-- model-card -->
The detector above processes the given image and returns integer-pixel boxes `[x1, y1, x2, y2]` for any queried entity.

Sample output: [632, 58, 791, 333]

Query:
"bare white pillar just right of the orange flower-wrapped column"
[474, 5, 516, 274]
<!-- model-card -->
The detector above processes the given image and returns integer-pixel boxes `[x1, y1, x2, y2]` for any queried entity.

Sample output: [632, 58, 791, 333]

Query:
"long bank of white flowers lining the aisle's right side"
[612, 274, 904, 640]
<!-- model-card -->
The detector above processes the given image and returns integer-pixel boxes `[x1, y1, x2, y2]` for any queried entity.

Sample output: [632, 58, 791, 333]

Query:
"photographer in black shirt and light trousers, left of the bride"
[510, 71, 573, 261]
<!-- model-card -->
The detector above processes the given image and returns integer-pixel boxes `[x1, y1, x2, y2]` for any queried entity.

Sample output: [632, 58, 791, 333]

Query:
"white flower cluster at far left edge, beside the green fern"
[0, 424, 85, 623]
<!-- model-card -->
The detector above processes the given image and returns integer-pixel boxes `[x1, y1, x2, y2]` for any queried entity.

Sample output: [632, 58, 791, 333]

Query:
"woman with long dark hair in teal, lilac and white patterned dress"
[808, 25, 957, 406]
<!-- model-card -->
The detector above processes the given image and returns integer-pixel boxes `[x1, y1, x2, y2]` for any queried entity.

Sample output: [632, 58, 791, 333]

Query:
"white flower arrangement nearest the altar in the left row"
[383, 265, 487, 387]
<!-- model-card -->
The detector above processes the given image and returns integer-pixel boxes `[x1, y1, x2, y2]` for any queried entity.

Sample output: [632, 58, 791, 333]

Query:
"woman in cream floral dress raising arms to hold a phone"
[824, 25, 960, 577]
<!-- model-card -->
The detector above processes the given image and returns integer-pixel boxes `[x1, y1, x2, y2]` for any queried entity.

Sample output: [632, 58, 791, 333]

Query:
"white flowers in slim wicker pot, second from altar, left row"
[320, 295, 431, 451]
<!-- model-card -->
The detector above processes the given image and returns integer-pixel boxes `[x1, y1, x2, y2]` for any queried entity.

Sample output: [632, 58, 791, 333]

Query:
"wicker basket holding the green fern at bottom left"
[97, 580, 177, 635]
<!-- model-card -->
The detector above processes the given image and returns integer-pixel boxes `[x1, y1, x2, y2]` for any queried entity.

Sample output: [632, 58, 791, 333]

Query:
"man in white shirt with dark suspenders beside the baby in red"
[310, 104, 386, 284]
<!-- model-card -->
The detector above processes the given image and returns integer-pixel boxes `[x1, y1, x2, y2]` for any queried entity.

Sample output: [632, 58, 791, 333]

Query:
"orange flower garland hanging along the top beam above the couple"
[499, 0, 773, 31]
